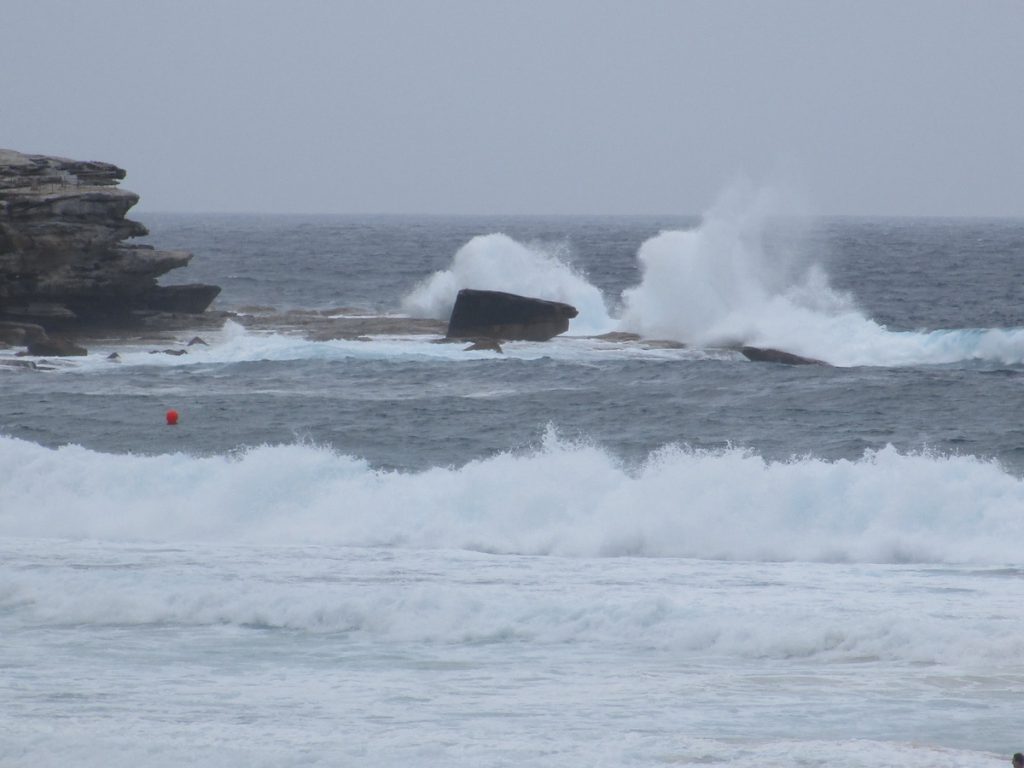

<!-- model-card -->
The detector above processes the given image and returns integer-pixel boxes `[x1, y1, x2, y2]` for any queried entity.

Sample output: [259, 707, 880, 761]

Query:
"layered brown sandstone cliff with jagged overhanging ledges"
[0, 150, 220, 329]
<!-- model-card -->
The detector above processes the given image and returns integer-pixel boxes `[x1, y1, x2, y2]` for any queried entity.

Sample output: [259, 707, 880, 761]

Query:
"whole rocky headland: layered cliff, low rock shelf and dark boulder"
[0, 150, 826, 369]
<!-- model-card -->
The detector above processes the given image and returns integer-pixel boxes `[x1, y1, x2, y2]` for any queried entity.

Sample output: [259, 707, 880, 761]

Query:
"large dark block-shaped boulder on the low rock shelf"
[447, 288, 579, 341]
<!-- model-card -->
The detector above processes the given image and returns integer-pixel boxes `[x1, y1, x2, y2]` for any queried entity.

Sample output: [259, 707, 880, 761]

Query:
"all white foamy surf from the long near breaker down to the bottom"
[6, 433, 1024, 768]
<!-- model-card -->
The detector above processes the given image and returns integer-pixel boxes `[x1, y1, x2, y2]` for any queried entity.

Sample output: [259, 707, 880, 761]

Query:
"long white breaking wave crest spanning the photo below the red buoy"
[0, 432, 1024, 563]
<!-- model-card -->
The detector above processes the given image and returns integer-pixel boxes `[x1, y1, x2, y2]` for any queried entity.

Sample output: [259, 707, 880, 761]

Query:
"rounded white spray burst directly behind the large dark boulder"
[402, 234, 613, 335]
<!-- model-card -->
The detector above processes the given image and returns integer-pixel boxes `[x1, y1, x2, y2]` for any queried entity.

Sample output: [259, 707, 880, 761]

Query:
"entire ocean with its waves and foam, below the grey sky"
[0, 195, 1024, 768]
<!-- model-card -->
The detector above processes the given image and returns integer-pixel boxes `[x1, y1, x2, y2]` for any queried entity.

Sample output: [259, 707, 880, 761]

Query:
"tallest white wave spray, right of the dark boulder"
[620, 185, 1024, 366]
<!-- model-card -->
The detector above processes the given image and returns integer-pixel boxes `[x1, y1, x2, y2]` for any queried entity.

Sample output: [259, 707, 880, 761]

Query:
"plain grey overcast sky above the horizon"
[0, 0, 1024, 216]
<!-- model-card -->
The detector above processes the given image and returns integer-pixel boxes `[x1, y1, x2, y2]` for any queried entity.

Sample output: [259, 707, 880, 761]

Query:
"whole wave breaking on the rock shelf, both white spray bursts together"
[395, 185, 1024, 367]
